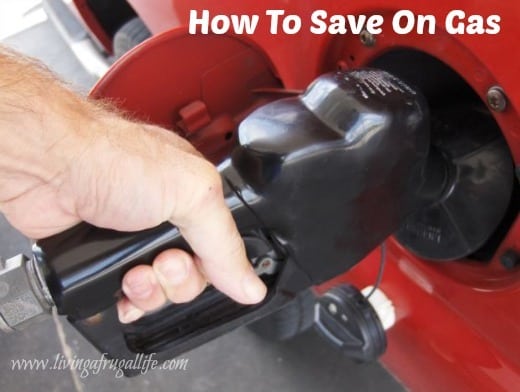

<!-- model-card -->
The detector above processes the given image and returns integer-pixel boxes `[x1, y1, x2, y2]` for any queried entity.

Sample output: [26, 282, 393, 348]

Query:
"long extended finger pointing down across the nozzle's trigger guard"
[172, 164, 267, 304]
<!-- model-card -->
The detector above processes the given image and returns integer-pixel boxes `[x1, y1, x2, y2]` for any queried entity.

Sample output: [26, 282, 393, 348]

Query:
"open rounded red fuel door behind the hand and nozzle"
[91, 28, 281, 163]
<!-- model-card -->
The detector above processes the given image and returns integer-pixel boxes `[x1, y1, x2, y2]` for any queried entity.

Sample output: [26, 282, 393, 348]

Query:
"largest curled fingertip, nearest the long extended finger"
[153, 249, 206, 303]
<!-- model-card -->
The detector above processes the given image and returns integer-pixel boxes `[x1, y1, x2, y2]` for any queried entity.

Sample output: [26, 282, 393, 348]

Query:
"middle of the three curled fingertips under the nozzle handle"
[122, 265, 166, 312]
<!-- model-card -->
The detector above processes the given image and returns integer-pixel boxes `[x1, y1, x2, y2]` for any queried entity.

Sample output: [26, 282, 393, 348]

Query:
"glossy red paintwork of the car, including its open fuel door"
[93, 0, 520, 392]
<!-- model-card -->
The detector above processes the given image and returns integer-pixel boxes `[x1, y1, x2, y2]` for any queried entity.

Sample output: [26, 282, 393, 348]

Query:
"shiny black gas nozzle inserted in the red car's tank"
[27, 69, 446, 374]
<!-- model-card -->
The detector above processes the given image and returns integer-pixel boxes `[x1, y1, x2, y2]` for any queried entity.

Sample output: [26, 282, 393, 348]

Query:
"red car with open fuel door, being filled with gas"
[45, 0, 520, 392]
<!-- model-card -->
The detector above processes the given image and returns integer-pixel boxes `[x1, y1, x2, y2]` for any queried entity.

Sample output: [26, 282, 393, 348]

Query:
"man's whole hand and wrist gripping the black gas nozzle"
[0, 46, 266, 322]
